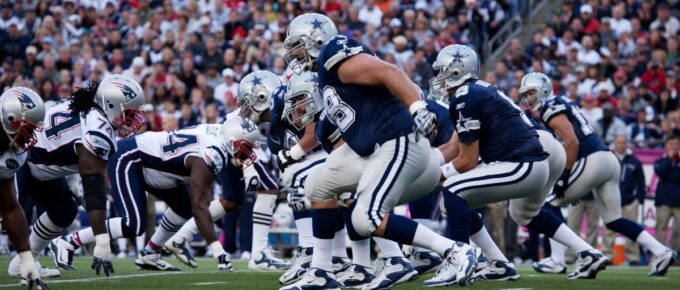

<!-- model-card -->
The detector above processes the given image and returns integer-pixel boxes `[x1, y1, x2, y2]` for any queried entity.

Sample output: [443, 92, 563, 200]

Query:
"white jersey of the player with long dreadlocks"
[28, 101, 116, 180]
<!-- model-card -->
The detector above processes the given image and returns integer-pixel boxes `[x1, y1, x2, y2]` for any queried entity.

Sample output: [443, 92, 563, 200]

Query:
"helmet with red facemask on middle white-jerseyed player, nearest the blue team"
[220, 116, 260, 168]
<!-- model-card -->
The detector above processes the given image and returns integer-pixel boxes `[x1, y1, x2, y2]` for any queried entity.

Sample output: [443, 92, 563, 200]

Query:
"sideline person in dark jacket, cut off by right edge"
[654, 135, 680, 250]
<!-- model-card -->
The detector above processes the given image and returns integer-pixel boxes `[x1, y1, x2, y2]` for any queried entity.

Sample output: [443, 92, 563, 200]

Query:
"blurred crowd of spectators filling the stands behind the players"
[0, 0, 680, 266]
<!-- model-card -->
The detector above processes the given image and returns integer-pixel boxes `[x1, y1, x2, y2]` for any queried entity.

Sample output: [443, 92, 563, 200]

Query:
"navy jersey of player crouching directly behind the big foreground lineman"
[449, 80, 548, 163]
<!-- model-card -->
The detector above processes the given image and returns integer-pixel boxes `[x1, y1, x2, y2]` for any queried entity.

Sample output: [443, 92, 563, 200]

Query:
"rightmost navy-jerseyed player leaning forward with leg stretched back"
[520, 73, 675, 276]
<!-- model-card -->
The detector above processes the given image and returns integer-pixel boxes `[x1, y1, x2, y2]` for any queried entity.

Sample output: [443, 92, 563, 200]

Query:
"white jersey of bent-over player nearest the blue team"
[135, 124, 229, 189]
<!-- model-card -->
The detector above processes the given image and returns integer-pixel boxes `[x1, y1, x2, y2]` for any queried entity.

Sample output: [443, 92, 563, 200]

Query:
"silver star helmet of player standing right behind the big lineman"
[430, 44, 480, 103]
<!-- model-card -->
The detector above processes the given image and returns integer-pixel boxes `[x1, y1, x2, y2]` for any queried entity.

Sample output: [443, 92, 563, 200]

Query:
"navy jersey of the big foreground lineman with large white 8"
[317, 35, 414, 156]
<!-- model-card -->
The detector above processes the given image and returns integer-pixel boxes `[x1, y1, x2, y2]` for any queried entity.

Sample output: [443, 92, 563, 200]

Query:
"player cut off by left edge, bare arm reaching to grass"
[0, 87, 47, 289]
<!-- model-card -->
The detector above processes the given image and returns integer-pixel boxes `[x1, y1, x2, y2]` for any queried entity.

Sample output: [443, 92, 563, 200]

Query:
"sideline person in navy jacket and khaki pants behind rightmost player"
[604, 135, 647, 265]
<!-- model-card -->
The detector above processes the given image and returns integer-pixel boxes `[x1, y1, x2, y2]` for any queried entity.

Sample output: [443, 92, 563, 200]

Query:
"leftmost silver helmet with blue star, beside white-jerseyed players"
[236, 70, 282, 124]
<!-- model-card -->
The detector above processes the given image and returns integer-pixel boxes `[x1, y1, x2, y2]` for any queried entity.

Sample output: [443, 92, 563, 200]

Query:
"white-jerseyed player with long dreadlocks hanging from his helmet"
[8, 75, 144, 275]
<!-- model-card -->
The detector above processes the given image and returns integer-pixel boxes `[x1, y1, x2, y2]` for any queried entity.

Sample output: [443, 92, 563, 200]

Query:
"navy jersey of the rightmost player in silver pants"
[540, 97, 609, 158]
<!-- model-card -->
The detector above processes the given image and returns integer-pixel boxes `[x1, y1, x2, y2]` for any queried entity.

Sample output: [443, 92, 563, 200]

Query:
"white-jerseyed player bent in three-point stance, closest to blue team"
[51, 118, 259, 272]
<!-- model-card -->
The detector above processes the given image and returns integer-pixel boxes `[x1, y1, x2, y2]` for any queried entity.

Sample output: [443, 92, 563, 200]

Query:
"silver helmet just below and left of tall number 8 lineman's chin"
[283, 71, 324, 130]
